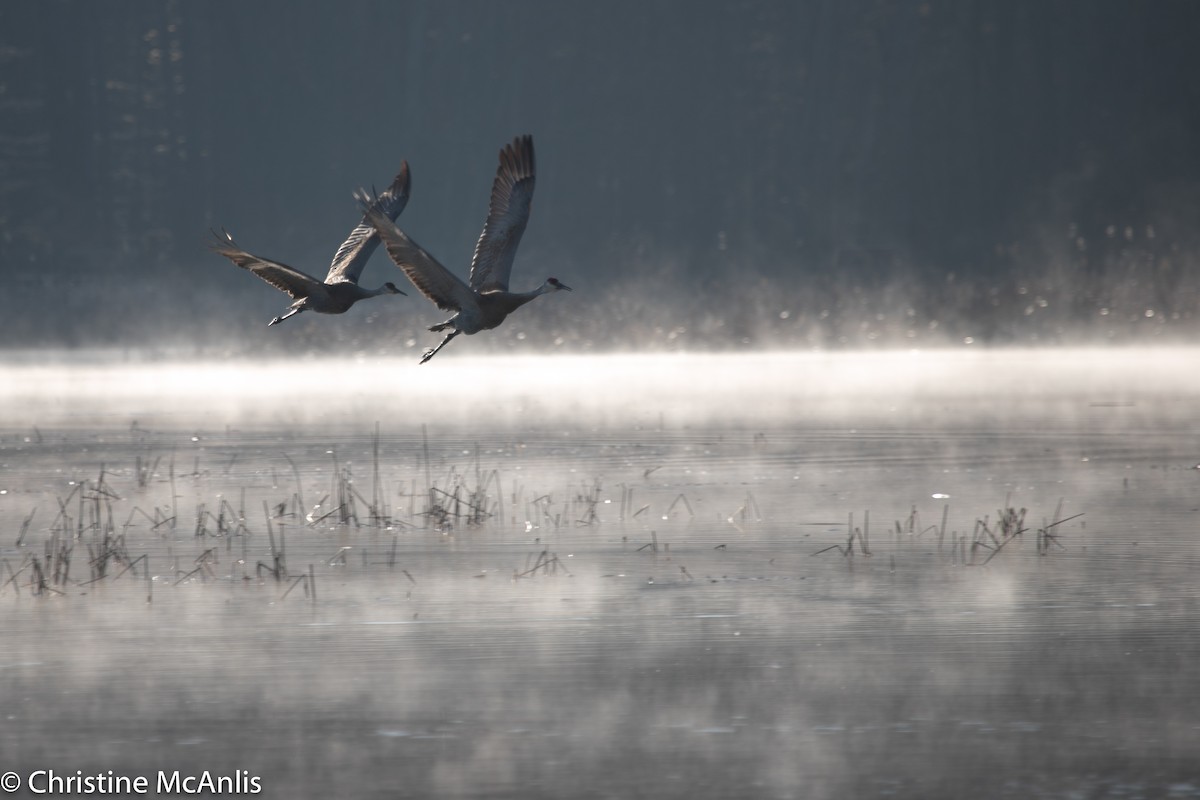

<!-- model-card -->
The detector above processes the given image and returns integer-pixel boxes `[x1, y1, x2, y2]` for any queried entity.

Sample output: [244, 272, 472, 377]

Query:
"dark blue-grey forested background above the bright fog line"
[0, 0, 1200, 353]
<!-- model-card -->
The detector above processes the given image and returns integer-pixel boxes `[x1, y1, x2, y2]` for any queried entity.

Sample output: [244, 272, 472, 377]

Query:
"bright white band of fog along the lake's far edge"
[9, 339, 1200, 419]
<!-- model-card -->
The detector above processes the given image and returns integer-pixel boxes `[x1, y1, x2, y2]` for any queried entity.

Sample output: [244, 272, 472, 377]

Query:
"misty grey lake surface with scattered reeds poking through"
[0, 348, 1200, 799]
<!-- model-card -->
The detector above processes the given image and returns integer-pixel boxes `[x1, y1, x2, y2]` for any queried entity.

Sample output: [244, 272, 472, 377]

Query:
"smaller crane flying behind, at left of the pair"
[212, 161, 409, 325]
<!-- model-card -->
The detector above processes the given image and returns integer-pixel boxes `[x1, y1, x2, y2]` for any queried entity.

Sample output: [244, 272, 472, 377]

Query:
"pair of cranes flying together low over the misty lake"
[212, 136, 570, 363]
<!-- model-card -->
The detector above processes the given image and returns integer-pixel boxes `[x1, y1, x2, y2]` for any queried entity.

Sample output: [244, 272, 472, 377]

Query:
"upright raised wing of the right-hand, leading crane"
[470, 136, 536, 291]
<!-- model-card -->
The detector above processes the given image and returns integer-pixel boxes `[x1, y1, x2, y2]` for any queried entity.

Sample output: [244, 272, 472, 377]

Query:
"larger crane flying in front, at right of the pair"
[355, 136, 570, 363]
